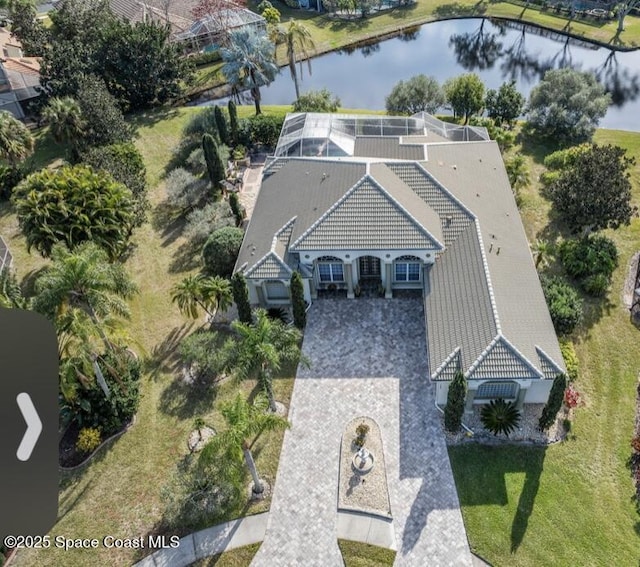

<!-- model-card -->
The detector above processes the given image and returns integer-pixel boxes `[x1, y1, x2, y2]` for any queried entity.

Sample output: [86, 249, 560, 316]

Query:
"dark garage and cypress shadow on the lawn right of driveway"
[449, 445, 547, 553]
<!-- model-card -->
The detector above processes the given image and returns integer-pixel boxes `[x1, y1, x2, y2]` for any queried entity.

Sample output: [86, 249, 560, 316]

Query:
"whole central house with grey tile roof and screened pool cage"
[236, 113, 565, 408]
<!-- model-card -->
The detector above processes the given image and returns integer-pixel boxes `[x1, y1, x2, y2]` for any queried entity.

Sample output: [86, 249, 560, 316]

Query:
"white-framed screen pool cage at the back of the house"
[275, 112, 489, 157]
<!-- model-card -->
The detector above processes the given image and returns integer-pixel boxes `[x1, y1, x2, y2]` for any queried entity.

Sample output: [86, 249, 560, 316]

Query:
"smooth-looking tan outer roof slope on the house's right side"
[422, 142, 564, 380]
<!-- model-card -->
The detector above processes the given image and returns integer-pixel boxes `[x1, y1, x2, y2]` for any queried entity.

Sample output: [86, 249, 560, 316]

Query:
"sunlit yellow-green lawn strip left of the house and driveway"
[5, 108, 293, 567]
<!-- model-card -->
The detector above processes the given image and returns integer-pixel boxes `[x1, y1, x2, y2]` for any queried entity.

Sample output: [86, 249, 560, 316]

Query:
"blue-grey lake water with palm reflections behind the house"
[198, 19, 640, 131]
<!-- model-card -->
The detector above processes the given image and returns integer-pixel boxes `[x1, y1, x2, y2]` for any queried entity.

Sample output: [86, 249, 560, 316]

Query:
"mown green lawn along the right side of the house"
[449, 130, 640, 567]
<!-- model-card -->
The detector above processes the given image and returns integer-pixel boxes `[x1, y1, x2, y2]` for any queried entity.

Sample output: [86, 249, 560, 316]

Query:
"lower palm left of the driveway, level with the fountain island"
[200, 392, 289, 494]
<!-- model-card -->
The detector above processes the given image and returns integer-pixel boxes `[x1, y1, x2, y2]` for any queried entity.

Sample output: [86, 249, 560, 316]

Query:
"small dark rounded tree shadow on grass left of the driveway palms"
[158, 376, 218, 420]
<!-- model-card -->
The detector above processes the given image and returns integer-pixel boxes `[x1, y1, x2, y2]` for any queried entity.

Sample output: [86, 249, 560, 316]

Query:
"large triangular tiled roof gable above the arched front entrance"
[291, 175, 442, 251]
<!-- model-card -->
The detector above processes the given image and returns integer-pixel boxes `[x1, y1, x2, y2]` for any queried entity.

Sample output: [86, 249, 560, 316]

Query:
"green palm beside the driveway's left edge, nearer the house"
[230, 309, 309, 412]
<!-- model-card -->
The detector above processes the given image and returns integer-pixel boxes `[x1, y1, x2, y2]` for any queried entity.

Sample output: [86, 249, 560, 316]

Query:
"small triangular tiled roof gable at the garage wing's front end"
[466, 334, 544, 380]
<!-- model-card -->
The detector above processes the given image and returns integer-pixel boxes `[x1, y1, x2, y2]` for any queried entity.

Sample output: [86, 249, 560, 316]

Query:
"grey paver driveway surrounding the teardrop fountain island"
[252, 298, 471, 567]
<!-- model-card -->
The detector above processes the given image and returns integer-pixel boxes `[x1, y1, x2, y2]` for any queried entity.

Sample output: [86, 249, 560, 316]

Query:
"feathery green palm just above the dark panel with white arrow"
[34, 242, 138, 350]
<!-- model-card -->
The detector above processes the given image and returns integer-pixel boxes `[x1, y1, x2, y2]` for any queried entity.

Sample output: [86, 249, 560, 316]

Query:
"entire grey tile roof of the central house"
[237, 115, 564, 386]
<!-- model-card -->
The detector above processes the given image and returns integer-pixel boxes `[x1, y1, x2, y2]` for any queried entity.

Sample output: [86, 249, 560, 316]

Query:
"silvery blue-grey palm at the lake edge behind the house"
[220, 29, 280, 114]
